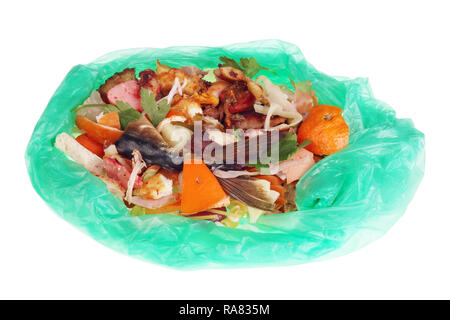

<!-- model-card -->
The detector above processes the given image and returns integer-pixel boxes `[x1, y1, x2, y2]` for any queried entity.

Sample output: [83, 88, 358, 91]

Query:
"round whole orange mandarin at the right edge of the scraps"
[298, 104, 349, 155]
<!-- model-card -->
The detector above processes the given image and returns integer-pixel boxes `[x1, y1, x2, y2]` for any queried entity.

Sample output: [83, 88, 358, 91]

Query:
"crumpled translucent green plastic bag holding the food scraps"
[25, 40, 425, 269]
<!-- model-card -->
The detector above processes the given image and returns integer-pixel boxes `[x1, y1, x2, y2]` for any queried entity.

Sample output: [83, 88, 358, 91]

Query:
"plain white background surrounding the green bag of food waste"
[0, 0, 450, 299]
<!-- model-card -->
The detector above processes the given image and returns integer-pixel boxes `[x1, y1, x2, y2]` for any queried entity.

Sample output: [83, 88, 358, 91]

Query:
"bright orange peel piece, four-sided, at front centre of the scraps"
[181, 161, 230, 214]
